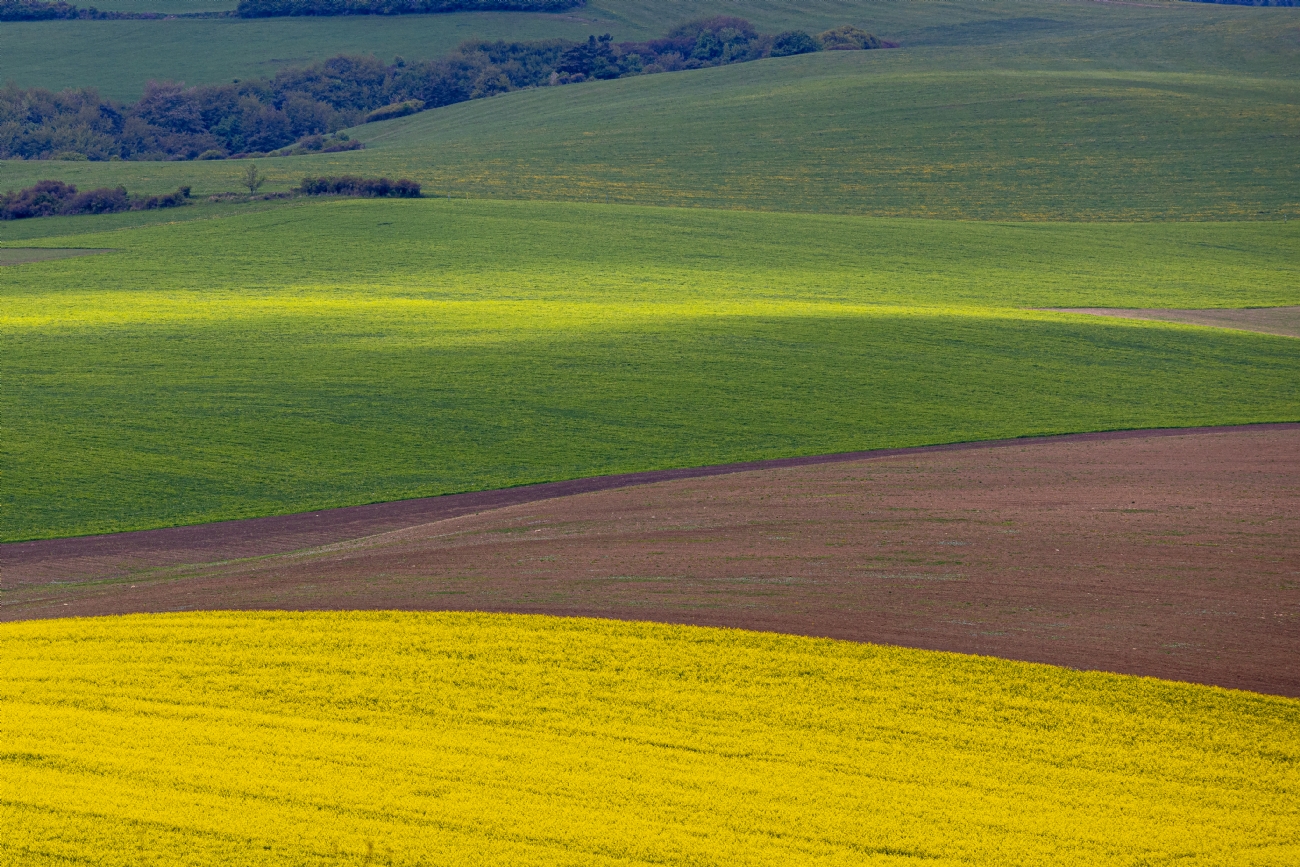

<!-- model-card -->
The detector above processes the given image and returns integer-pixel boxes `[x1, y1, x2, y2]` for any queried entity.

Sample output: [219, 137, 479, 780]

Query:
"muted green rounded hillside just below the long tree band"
[0, 48, 1300, 220]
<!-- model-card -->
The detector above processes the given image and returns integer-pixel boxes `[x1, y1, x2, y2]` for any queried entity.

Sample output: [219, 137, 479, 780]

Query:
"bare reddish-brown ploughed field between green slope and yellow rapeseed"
[0, 425, 1300, 697]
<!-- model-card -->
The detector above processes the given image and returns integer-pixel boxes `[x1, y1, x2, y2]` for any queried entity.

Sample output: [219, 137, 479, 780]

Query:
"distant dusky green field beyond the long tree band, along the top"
[0, 0, 1300, 100]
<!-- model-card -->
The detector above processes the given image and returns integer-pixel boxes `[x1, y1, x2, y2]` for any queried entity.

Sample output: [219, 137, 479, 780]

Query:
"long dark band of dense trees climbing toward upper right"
[0, 18, 892, 160]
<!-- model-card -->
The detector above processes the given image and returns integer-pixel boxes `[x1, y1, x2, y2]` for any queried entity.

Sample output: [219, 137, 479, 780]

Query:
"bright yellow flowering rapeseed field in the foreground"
[0, 612, 1300, 867]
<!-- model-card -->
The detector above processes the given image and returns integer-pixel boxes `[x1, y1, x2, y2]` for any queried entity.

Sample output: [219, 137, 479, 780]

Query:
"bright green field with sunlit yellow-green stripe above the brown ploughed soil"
[0, 200, 1300, 539]
